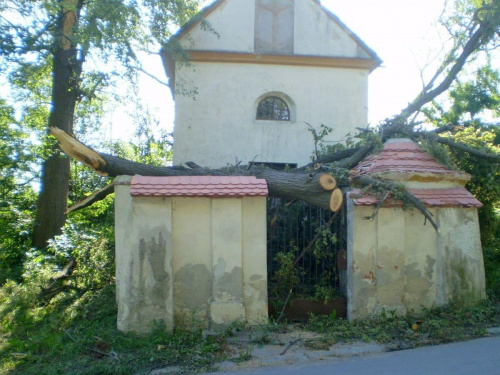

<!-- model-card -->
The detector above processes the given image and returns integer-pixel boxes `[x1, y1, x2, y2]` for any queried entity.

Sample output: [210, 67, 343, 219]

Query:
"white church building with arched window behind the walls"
[162, 0, 381, 168]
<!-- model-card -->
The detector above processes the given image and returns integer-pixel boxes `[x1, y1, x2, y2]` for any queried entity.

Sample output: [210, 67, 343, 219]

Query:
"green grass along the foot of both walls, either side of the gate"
[0, 274, 500, 375]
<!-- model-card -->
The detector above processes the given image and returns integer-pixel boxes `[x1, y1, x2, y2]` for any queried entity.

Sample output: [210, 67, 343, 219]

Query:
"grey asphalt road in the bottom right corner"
[223, 337, 500, 375]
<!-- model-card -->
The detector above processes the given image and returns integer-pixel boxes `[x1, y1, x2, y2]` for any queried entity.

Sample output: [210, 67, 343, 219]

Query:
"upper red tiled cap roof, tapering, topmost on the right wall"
[353, 139, 464, 175]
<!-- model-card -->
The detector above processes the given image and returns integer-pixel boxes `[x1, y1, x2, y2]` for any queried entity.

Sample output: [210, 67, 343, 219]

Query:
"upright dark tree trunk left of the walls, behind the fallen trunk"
[32, 0, 82, 248]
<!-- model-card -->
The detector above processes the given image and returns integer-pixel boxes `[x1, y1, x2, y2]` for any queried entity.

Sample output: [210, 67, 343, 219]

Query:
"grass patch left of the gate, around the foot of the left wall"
[0, 285, 227, 375]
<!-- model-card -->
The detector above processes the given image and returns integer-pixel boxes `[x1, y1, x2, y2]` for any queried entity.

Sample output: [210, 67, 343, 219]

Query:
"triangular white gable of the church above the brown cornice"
[177, 0, 380, 65]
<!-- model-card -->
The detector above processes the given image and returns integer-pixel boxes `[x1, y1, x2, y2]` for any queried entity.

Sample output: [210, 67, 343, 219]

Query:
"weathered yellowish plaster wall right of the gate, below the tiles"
[348, 202, 485, 320]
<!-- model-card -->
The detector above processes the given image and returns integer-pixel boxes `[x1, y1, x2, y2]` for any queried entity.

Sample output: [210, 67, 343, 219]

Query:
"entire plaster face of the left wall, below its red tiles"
[115, 181, 267, 332]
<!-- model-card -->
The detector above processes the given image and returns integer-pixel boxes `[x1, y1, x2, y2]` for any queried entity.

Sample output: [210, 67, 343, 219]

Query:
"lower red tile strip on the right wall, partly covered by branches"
[352, 187, 482, 207]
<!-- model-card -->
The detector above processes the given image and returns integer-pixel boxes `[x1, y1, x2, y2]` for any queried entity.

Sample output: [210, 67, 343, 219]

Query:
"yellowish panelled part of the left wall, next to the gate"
[173, 197, 267, 328]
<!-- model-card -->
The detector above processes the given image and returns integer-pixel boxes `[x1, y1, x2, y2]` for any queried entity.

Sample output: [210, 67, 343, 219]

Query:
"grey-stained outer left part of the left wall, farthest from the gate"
[115, 178, 174, 333]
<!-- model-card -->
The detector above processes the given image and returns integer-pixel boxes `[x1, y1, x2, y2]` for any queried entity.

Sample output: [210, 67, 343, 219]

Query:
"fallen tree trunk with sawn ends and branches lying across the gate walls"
[51, 128, 500, 231]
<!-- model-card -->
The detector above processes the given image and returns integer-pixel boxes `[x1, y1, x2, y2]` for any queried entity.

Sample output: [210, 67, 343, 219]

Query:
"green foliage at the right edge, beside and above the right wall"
[423, 65, 500, 299]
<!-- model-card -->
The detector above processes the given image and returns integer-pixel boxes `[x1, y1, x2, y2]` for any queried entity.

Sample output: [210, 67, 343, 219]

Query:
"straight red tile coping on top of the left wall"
[130, 176, 268, 198]
